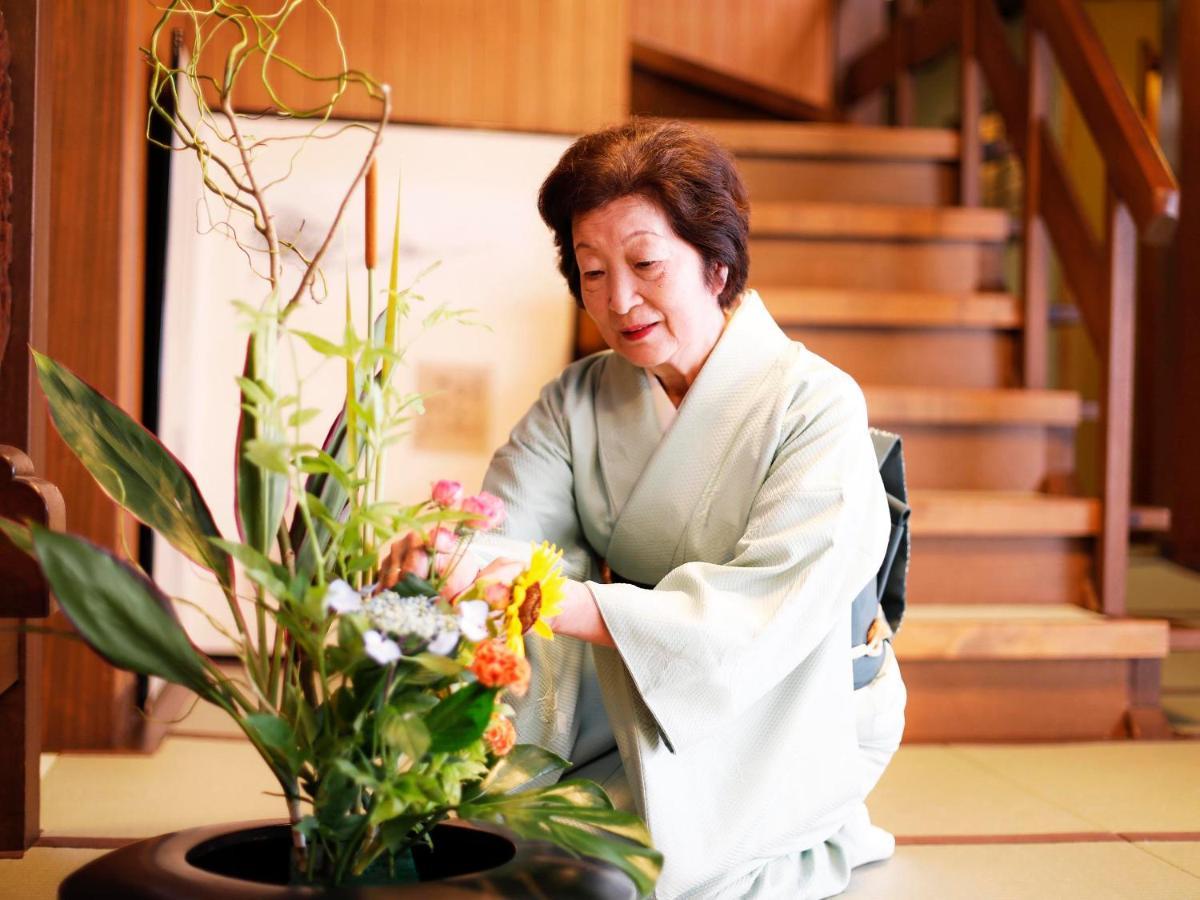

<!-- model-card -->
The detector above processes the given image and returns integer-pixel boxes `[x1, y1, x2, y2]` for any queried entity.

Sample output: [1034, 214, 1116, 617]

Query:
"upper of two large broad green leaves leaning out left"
[32, 350, 233, 588]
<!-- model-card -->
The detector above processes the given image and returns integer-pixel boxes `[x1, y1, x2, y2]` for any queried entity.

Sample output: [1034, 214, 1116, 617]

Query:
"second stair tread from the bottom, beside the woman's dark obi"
[908, 490, 1100, 538]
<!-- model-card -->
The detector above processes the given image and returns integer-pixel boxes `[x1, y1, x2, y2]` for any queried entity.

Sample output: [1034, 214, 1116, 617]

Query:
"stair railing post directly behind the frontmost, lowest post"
[1022, 20, 1051, 389]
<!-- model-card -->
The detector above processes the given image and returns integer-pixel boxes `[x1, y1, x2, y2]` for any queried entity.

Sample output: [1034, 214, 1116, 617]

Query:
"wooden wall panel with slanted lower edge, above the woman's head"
[630, 0, 835, 106]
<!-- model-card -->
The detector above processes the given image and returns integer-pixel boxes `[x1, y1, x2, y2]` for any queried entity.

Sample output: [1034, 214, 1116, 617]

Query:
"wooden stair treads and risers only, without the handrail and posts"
[697, 121, 1168, 740]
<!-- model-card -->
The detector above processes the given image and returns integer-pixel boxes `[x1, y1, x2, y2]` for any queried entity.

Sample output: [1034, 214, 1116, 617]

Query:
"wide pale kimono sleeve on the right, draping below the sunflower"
[588, 377, 889, 749]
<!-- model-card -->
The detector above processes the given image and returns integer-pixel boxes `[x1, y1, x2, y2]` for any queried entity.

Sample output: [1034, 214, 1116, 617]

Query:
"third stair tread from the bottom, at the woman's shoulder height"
[863, 385, 1082, 428]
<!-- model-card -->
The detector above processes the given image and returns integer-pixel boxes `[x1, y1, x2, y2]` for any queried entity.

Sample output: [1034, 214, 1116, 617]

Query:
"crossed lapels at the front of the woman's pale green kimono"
[596, 290, 791, 584]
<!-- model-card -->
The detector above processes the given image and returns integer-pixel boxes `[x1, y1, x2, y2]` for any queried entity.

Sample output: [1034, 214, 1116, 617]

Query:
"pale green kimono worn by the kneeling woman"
[485, 292, 889, 898]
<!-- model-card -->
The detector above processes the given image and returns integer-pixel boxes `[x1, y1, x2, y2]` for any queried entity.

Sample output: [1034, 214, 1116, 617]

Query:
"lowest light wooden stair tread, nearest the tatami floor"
[895, 604, 1169, 664]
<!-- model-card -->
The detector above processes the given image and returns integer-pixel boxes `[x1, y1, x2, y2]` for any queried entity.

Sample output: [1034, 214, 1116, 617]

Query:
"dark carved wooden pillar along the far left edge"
[0, 0, 62, 857]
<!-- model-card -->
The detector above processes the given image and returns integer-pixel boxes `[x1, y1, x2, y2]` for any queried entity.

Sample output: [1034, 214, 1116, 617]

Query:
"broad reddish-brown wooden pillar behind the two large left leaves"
[42, 0, 155, 749]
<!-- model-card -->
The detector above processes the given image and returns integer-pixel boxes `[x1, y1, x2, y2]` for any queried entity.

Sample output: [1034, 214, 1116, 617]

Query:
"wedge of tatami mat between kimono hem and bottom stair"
[866, 745, 1096, 835]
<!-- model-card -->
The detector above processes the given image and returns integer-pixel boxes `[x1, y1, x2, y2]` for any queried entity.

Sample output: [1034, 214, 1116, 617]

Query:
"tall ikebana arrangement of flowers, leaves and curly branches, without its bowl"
[0, 0, 661, 893]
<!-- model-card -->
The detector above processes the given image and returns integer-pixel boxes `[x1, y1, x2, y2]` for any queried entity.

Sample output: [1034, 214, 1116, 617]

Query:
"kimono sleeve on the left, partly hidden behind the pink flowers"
[484, 378, 590, 578]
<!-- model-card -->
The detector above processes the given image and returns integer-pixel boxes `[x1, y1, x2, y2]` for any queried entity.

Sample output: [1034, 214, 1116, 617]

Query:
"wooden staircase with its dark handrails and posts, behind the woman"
[609, 0, 1180, 742]
